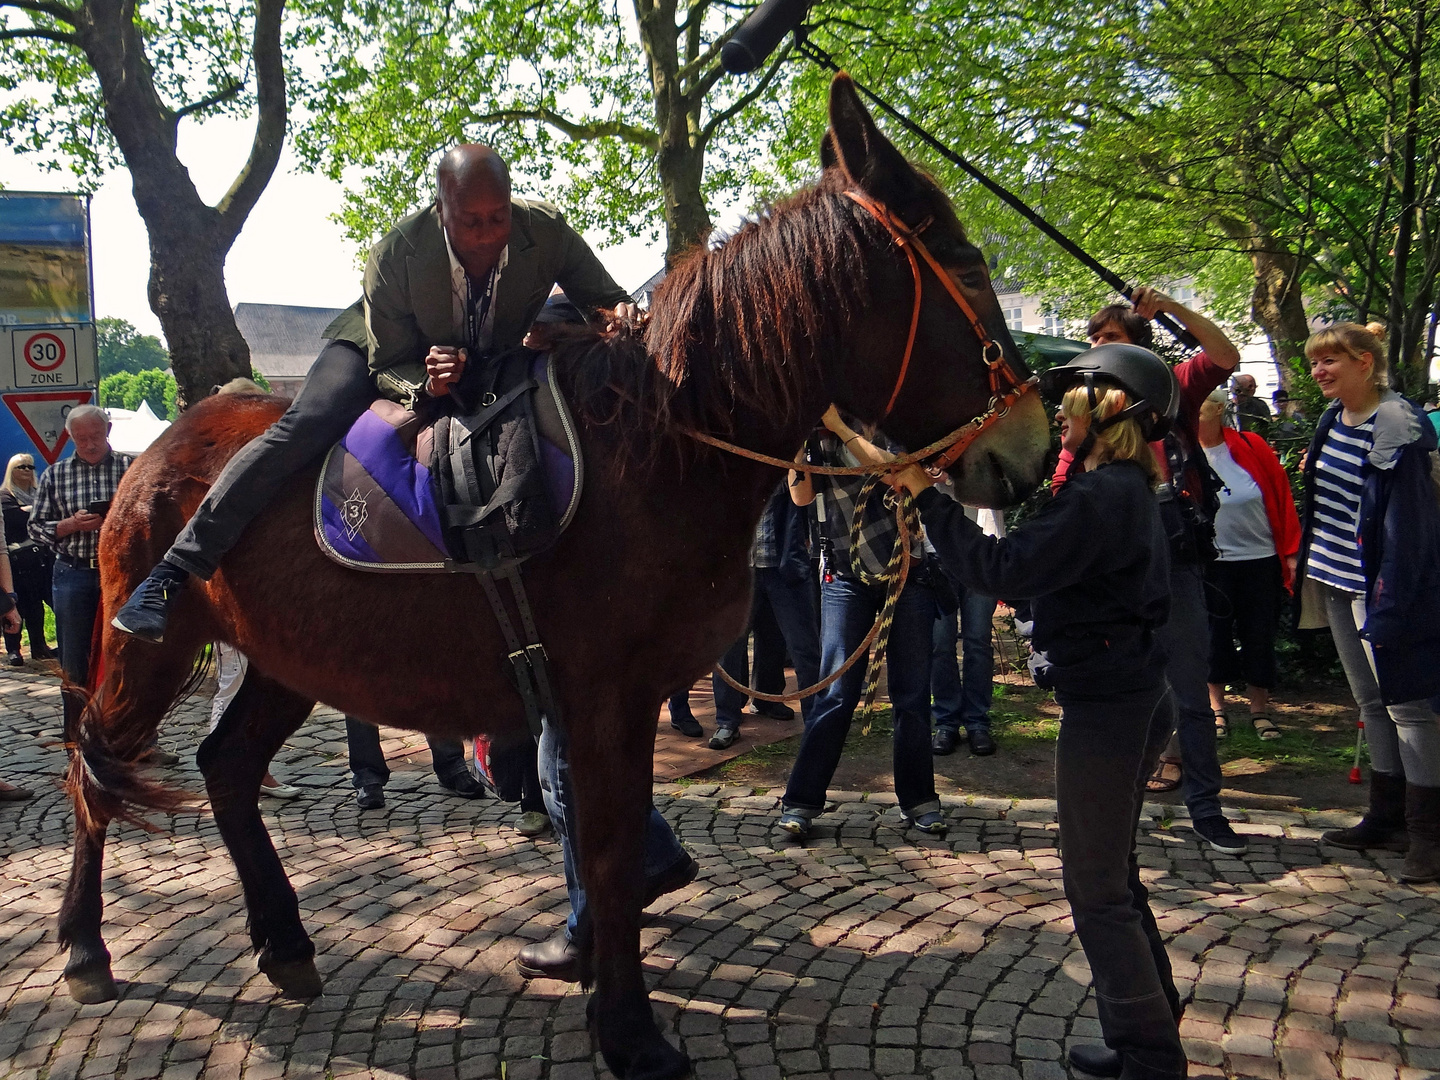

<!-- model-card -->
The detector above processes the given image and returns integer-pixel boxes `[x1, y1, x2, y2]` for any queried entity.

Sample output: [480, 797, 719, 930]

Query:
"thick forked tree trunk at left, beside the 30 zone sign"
[76, 0, 287, 403]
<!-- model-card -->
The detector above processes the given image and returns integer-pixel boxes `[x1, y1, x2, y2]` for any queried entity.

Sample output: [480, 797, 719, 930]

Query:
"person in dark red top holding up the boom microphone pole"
[1051, 287, 1247, 855]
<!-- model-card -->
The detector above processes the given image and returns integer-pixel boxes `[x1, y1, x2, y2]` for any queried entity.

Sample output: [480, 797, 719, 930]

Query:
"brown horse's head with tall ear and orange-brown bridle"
[819, 75, 1050, 507]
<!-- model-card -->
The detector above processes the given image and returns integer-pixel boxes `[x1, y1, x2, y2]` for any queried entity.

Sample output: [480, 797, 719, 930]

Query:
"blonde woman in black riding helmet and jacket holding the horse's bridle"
[897, 344, 1187, 1080]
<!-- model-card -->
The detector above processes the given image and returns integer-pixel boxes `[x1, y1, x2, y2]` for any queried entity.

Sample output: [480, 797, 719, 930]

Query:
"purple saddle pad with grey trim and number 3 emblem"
[315, 354, 583, 573]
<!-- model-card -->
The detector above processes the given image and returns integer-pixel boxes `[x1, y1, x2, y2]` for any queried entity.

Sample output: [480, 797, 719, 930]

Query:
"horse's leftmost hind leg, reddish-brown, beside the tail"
[58, 641, 203, 1005]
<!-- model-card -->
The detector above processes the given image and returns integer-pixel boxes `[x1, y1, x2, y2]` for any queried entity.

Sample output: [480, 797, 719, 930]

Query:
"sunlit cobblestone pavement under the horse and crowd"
[0, 675, 1440, 1080]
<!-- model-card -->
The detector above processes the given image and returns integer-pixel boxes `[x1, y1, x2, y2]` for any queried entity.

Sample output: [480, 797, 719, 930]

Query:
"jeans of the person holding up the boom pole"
[1155, 564, 1221, 821]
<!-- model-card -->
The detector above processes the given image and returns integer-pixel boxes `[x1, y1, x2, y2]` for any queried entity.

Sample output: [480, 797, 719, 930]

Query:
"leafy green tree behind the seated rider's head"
[297, 0, 786, 258]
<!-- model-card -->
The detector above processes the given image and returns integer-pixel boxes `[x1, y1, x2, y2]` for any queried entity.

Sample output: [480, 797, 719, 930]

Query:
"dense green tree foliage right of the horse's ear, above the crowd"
[788, 0, 1440, 387]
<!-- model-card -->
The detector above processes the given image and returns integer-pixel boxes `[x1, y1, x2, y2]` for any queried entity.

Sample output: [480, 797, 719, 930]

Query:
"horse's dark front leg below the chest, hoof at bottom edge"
[570, 698, 690, 1080]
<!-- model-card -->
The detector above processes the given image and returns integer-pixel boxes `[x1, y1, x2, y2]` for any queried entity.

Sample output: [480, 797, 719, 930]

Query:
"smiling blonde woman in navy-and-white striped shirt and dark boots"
[1297, 323, 1440, 883]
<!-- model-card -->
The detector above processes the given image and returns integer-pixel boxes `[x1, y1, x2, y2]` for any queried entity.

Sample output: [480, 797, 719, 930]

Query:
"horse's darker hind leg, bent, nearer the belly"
[196, 665, 321, 998]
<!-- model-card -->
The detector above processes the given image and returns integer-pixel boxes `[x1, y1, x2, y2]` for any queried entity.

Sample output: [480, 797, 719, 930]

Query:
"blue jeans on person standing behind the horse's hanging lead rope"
[785, 567, 940, 818]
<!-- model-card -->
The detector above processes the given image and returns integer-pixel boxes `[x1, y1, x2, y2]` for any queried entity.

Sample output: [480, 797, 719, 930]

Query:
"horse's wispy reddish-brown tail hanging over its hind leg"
[62, 648, 210, 832]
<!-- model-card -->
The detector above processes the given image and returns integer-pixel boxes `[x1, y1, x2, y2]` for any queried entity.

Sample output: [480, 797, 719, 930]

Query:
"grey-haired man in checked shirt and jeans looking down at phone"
[30, 405, 131, 685]
